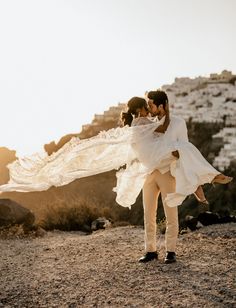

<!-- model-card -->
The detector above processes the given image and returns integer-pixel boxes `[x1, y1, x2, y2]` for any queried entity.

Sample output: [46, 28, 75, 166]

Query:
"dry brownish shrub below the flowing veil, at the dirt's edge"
[40, 199, 113, 232]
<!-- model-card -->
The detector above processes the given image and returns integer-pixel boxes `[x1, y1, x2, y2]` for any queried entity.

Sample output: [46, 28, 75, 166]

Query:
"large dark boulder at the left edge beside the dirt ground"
[0, 199, 35, 231]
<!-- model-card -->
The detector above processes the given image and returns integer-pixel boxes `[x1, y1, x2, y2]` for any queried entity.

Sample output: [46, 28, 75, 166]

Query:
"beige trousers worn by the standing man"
[143, 170, 179, 252]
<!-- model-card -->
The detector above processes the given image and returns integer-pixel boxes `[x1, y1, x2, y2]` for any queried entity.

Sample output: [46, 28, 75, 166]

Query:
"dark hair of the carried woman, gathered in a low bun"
[121, 96, 147, 126]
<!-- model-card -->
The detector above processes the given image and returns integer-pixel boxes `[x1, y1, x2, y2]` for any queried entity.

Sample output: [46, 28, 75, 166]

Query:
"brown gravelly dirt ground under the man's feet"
[0, 223, 236, 308]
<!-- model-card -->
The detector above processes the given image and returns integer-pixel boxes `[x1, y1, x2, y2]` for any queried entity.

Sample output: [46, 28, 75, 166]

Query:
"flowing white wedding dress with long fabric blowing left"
[0, 118, 220, 207]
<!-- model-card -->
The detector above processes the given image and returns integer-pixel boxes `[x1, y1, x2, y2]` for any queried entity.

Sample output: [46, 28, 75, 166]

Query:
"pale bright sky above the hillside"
[0, 0, 236, 156]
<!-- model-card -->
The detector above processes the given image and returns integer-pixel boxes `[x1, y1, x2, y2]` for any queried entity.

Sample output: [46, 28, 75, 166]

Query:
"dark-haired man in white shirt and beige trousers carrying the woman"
[139, 91, 188, 264]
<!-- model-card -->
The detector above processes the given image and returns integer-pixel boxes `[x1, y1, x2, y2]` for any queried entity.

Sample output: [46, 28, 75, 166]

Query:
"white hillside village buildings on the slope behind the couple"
[80, 70, 236, 171]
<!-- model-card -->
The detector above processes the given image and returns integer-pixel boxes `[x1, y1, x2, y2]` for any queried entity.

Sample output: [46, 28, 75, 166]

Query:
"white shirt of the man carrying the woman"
[154, 116, 188, 174]
